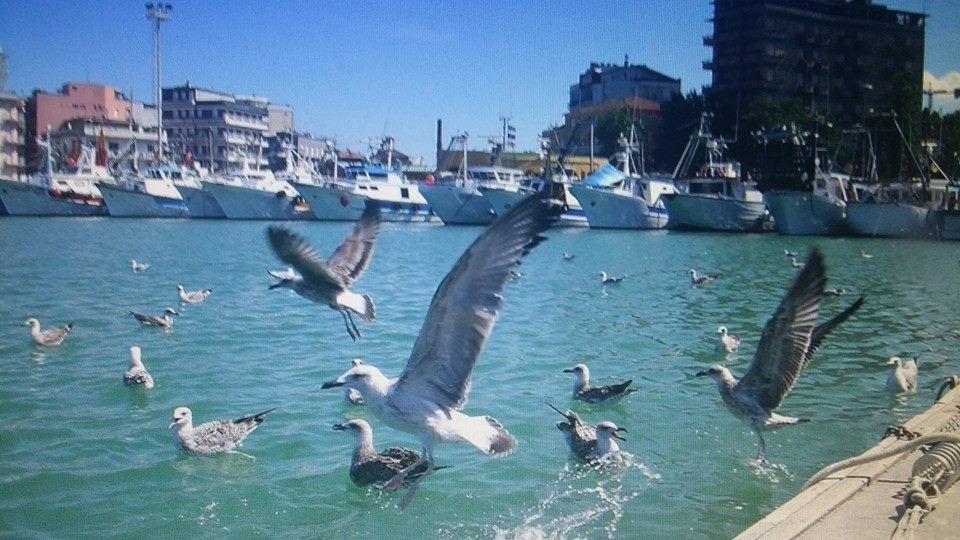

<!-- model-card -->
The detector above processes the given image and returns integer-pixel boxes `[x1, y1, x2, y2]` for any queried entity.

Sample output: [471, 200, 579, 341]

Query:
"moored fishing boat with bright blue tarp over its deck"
[570, 126, 676, 229]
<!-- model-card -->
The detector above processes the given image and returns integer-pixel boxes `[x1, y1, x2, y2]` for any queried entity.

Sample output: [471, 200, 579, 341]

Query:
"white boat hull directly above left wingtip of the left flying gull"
[203, 182, 316, 220]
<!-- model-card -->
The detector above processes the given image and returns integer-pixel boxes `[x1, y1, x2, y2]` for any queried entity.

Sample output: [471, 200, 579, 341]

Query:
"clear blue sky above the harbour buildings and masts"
[0, 0, 960, 161]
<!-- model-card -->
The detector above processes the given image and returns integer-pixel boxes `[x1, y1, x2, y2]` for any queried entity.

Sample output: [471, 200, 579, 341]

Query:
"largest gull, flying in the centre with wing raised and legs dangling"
[323, 193, 563, 506]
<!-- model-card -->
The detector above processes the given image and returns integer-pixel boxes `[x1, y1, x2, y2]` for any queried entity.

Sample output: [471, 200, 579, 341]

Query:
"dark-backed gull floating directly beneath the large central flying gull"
[333, 419, 445, 487]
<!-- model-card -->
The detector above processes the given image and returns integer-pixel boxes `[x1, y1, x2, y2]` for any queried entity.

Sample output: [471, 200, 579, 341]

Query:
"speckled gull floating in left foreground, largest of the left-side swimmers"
[170, 407, 273, 456]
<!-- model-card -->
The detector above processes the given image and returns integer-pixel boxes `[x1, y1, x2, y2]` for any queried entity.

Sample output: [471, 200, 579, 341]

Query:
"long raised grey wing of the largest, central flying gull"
[394, 194, 562, 408]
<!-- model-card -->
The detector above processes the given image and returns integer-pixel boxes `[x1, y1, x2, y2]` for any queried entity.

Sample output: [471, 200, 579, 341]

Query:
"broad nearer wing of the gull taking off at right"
[737, 249, 827, 409]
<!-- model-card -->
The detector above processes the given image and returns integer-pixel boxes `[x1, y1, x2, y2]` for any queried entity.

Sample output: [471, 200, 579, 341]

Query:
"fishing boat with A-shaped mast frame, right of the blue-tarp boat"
[662, 113, 770, 232]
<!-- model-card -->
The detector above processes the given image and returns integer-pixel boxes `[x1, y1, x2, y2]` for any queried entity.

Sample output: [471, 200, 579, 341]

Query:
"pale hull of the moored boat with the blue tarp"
[570, 184, 667, 229]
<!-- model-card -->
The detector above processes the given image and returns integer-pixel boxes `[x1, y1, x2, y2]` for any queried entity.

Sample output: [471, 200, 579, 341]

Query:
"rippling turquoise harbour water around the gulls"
[0, 218, 960, 538]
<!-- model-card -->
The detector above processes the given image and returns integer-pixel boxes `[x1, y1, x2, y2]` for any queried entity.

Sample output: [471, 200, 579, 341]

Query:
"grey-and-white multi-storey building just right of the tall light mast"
[162, 81, 270, 171]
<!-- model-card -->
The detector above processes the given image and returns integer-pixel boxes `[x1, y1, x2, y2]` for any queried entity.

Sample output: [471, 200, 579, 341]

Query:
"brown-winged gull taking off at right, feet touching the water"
[696, 249, 864, 462]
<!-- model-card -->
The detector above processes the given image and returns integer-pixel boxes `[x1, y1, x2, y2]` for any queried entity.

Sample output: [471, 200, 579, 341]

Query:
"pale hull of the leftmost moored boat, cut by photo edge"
[0, 180, 107, 216]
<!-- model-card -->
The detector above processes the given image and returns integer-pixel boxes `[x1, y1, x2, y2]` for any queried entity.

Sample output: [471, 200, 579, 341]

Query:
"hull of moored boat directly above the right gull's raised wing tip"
[763, 190, 845, 236]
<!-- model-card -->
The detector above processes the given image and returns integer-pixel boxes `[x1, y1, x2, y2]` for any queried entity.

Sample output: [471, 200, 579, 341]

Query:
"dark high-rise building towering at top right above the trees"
[703, 0, 926, 123]
